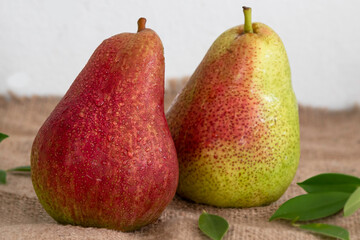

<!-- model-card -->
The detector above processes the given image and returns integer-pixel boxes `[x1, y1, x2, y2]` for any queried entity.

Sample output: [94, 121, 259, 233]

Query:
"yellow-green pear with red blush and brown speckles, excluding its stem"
[166, 23, 300, 207]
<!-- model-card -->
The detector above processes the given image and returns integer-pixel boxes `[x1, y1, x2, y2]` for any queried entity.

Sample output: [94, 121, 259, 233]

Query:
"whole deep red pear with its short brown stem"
[31, 18, 178, 231]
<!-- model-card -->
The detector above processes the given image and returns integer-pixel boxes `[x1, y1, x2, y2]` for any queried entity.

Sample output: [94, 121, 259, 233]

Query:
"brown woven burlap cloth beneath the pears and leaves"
[0, 82, 360, 240]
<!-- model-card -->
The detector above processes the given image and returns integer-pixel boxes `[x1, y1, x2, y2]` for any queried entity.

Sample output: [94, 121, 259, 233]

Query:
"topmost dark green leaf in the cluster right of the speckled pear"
[298, 173, 360, 193]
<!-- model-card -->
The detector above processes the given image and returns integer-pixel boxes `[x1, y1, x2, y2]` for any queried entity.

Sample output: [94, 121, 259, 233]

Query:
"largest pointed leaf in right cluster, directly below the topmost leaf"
[269, 192, 350, 221]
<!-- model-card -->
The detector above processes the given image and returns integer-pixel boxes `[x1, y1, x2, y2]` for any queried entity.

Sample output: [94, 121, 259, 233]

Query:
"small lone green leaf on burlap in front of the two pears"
[199, 212, 229, 240]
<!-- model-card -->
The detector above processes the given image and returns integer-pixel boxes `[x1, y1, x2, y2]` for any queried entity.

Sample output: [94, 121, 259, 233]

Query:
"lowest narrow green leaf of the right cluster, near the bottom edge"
[299, 223, 350, 240]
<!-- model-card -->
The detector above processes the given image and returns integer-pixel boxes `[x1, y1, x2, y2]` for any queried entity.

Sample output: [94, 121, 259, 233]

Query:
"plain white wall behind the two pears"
[0, 0, 360, 109]
